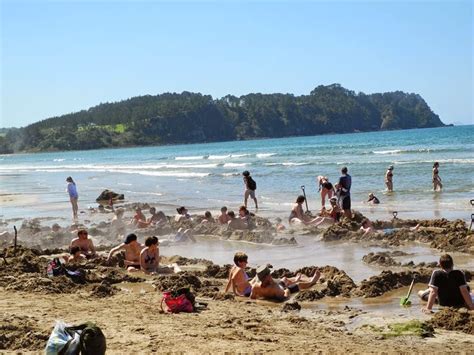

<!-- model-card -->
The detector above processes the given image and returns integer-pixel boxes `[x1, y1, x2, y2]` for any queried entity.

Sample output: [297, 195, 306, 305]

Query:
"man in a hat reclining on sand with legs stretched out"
[250, 265, 321, 301]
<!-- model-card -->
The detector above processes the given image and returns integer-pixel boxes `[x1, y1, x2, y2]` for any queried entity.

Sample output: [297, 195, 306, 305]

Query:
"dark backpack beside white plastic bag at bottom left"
[58, 322, 107, 355]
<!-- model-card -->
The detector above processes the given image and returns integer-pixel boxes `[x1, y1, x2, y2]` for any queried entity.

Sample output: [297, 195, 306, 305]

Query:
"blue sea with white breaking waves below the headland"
[0, 125, 474, 221]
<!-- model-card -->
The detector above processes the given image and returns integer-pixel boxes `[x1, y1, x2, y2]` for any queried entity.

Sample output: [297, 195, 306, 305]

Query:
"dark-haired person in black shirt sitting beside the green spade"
[418, 254, 474, 313]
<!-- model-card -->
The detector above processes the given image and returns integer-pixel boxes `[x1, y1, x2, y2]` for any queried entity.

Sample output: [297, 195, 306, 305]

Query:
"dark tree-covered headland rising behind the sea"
[0, 84, 444, 154]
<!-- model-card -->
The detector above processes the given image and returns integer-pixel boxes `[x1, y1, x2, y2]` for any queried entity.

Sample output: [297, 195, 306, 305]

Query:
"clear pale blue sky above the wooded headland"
[0, 0, 474, 127]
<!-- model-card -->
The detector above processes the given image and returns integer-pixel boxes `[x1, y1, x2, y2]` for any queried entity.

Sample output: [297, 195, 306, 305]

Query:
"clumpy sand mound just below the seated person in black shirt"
[429, 308, 474, 335]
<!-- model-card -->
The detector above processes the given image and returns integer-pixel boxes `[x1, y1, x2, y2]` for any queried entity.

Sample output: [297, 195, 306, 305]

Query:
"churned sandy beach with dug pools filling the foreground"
[0, 204, 474, 353]
